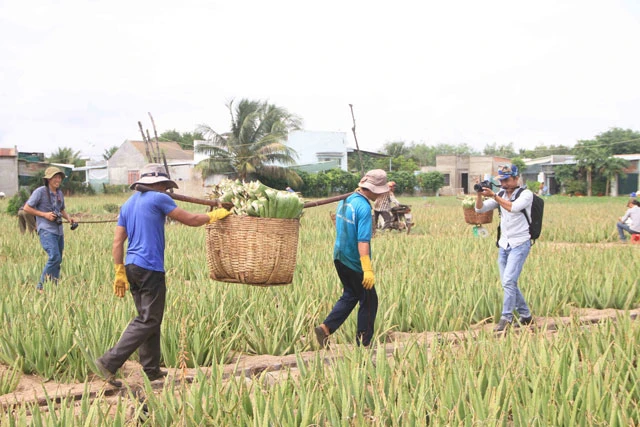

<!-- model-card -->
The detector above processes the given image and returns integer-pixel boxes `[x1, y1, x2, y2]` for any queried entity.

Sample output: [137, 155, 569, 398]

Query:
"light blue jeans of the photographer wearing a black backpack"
[498, 240, 531, 322]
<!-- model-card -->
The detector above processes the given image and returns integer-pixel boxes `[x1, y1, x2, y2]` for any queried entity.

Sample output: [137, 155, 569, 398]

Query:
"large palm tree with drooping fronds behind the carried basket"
[197, 99, 302, 186]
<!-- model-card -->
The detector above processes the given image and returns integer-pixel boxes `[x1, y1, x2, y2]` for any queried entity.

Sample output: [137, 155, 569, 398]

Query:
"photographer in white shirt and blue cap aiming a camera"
[473, 165, 533, 332]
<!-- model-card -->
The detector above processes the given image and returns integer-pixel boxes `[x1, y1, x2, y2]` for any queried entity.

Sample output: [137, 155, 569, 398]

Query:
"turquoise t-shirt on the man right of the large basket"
[333, 193, 373, 273]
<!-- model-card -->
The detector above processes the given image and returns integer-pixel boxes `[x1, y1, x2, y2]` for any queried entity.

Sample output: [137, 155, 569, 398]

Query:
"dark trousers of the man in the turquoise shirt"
[322, 260, 378, 345]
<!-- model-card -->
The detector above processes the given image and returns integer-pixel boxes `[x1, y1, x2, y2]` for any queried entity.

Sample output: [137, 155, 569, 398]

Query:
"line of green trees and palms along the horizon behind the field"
[41, 99, 640, 197]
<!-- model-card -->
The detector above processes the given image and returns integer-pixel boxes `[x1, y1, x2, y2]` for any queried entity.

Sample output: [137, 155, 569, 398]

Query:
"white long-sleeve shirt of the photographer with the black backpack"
[476, 189, 533, 249]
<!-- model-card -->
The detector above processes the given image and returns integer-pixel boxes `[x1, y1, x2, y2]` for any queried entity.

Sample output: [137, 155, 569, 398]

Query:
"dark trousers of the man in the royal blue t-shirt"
[99, 264, 167, 374]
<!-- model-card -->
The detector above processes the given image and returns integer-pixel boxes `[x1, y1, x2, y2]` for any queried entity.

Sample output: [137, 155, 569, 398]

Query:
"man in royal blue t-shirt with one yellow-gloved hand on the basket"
[94, 163, 230, 387]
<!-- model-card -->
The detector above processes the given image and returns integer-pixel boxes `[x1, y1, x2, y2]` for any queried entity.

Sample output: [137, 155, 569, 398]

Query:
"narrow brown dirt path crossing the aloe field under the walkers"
[0, 309, 640, 422]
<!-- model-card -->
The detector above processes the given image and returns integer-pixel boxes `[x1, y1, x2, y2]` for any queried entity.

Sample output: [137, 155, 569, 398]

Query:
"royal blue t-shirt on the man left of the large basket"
[118, 191, 177, 272]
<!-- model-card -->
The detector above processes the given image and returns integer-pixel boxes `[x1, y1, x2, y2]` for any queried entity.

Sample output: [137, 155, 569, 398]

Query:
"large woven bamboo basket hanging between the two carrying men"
[206, 215, 300, 286]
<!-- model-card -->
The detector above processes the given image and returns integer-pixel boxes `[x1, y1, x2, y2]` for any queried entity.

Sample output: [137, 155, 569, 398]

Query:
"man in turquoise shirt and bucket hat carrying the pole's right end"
[315, 169, 389, 348]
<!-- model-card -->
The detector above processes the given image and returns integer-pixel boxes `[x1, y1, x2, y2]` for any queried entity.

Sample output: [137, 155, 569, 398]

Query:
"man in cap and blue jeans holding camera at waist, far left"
[24, 166, 75, 292]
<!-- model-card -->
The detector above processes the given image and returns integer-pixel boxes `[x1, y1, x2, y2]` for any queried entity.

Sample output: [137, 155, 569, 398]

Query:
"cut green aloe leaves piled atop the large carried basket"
[208, 179, 304, 219]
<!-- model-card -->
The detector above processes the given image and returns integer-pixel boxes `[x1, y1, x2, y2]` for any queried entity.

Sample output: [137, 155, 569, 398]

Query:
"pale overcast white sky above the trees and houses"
[0, 0, 640, 160]
